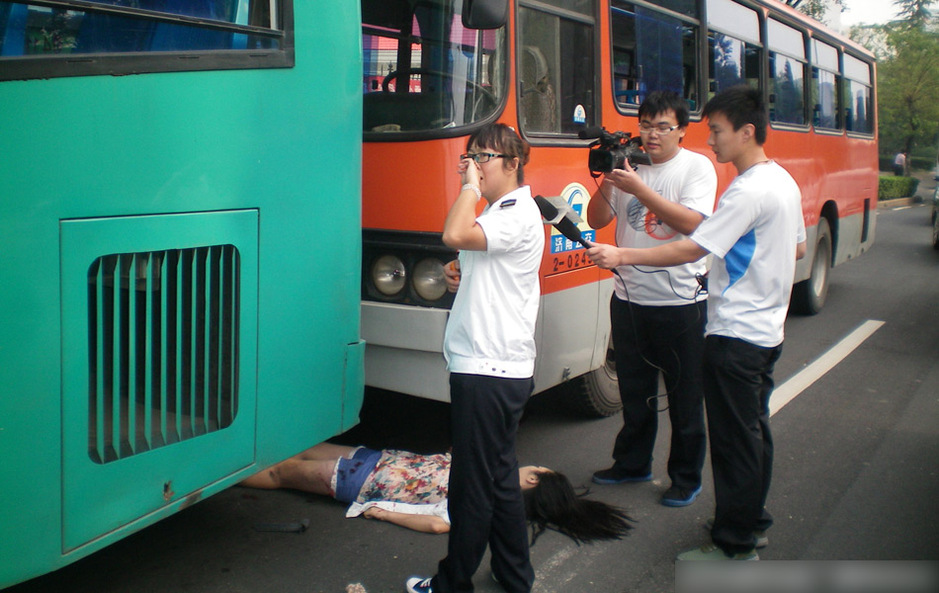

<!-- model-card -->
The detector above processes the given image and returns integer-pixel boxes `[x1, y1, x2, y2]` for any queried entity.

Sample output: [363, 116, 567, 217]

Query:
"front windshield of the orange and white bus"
[362, 0, 505, 134]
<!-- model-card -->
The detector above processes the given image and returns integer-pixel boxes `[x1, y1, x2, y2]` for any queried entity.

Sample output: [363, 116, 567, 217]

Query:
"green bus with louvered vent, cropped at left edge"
[0, 0, 364, 588]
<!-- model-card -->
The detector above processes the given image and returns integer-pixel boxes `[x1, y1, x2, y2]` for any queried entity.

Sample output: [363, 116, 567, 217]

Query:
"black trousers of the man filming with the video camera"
[610, 295, 707, 490]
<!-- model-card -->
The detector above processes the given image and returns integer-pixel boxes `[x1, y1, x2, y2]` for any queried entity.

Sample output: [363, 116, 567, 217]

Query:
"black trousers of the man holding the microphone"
[704, 336, 782, 554]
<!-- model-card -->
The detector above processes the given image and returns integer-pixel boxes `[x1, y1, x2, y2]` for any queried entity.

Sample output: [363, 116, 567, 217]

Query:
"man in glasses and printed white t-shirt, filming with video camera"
[587, 91, 717, 507]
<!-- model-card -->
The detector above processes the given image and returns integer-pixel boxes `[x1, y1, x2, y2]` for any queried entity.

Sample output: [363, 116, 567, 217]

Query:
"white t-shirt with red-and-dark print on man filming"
[612, 148, 717, 306]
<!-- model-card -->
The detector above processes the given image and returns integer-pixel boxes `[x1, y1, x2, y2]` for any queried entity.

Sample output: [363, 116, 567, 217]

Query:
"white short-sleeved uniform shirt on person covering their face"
[443, 186, 545, 379]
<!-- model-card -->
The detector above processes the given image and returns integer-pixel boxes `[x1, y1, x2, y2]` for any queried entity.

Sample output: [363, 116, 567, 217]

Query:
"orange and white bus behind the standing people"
[362, 0, 878, 414]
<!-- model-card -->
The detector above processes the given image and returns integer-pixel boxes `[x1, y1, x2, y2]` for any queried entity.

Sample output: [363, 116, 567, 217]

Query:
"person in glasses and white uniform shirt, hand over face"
[406, 124, 545, 593]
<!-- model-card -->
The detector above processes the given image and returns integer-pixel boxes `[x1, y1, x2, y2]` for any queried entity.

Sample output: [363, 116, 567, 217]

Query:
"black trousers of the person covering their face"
[432, 373, 535, 593]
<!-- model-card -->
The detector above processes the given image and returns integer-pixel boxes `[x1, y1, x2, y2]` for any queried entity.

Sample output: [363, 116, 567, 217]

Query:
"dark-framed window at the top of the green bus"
[0, 0, 289, 80]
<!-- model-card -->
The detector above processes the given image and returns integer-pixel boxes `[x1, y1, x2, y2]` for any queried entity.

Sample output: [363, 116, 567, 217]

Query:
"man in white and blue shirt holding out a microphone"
[588, 86, 805, 560]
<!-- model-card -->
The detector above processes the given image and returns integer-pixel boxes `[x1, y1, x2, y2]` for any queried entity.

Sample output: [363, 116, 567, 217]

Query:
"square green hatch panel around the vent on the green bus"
[60, 210, 258, 551]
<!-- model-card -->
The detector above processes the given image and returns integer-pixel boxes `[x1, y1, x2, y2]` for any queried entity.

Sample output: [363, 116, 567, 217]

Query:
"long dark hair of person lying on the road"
[522, 471, 633, 544]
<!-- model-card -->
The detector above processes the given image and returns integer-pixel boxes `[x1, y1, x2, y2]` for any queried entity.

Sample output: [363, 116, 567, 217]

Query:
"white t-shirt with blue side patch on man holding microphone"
[691, 161, 805, 348]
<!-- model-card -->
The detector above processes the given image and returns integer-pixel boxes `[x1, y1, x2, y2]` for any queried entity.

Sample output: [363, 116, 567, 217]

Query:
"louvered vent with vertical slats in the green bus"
[88, 245, 240, 463]
